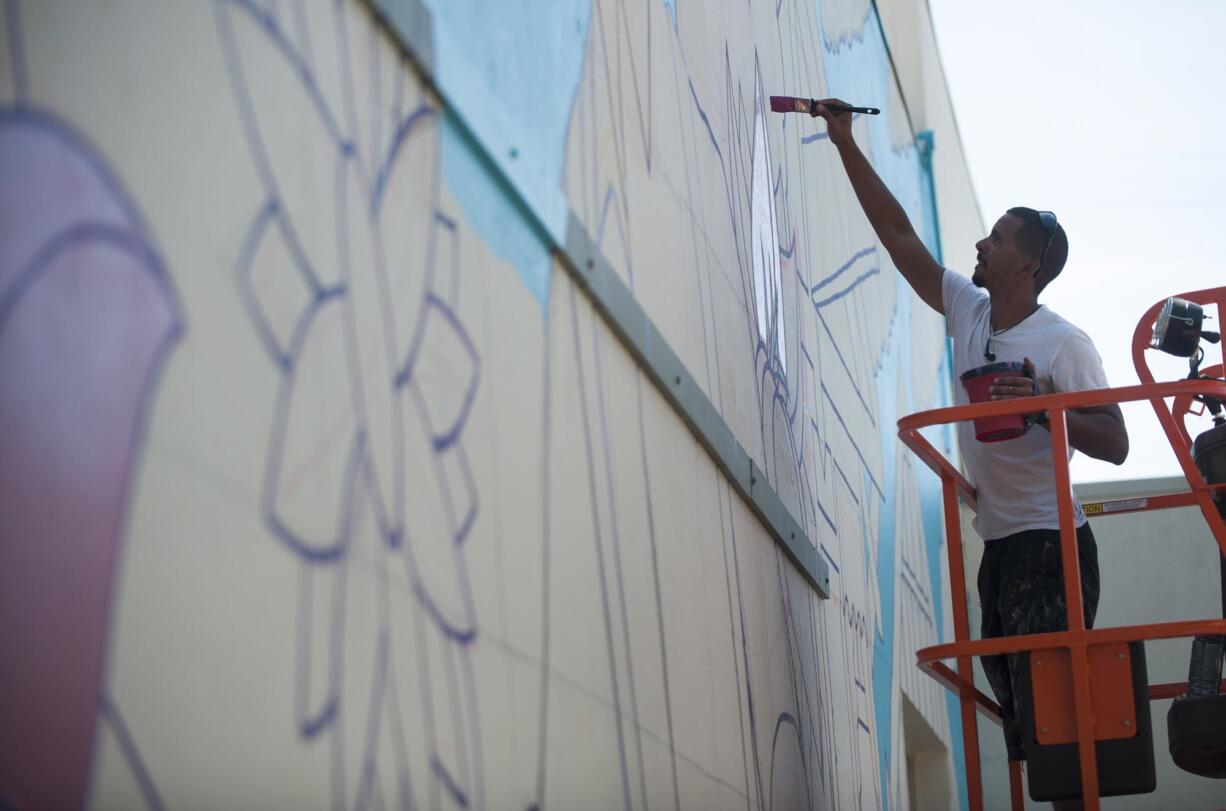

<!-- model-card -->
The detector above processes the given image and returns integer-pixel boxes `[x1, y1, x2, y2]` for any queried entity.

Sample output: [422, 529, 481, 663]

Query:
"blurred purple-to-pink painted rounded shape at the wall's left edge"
[0, 115, 175, 809]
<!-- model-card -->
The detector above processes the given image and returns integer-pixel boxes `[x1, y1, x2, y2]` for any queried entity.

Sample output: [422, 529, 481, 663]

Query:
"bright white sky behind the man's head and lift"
[929, 0, 1226, 481]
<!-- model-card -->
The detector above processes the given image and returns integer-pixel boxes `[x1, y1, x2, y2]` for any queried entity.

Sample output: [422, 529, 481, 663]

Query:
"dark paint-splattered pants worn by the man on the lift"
[978, 523, 1098, 761]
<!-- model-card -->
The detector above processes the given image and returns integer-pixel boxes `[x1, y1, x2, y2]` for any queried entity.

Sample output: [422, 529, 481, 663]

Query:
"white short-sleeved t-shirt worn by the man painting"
[940, 270, 1107, 540]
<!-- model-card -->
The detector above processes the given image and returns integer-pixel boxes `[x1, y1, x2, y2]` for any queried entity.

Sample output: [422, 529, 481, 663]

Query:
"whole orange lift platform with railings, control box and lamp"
[899, 287, 1226, 811]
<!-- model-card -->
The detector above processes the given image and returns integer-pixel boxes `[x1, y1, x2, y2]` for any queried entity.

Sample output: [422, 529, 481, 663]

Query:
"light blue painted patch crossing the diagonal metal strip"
[424, 0, 591, 307]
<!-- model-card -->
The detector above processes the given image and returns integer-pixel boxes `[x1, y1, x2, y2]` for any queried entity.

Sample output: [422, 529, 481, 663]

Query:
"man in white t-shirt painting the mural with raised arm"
[814, 99, 1128, 798]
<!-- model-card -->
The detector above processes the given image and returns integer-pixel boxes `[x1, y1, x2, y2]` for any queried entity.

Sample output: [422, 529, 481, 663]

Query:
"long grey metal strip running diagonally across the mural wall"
[365, 0, 830, 599]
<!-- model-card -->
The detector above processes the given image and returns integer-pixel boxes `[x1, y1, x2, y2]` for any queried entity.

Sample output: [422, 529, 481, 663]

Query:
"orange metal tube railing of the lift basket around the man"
[899, 382, 1226, 811]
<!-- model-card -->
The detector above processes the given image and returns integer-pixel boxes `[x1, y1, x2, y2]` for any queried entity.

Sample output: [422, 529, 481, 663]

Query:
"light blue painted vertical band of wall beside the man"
[812, 0, 967, 809]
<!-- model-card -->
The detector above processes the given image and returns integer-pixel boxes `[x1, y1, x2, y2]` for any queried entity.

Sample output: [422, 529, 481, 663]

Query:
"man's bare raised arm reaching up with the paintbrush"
[817, 99, 945, 314]
